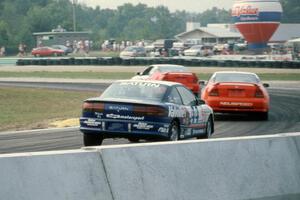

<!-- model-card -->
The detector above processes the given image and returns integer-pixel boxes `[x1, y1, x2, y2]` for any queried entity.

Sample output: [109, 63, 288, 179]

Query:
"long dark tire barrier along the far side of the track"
[16, 57, 300, 69]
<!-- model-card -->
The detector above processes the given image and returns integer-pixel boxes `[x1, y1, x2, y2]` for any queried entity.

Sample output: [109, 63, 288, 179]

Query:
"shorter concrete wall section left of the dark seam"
[0, 151, 112, 200]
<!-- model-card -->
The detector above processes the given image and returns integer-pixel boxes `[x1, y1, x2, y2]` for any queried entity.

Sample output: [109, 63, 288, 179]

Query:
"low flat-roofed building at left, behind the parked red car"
[33, 26, 91, 46]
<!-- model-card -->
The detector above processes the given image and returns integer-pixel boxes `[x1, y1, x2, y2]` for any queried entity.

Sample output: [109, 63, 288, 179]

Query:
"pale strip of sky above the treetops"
[78, 0, 234, 12]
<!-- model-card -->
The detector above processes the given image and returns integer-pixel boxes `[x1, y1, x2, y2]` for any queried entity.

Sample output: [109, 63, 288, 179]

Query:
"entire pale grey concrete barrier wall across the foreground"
[0, 133, 300, 200]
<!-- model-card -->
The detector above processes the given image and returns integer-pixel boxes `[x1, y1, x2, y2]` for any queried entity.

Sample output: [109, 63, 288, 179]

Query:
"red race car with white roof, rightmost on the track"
[201, 71, 270, 120]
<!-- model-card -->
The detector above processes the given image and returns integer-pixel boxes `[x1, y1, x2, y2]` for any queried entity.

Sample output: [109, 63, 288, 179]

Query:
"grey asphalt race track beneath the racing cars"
[0, 83, 300, 153]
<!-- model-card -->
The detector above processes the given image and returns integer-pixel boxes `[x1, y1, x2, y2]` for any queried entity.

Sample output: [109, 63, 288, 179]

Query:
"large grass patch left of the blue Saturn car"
[0, 87, 99, 131]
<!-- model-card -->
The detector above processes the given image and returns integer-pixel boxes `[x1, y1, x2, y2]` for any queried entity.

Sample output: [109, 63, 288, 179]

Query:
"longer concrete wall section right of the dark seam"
[100, 134, 300, 200]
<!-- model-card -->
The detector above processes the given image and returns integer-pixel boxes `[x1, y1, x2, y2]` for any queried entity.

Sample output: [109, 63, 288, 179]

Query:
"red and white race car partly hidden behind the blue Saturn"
[132, 64, 200, 96]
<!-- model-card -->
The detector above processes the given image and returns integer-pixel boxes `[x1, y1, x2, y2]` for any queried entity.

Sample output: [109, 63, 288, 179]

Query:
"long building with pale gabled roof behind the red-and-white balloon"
[175, 24, 300, 44]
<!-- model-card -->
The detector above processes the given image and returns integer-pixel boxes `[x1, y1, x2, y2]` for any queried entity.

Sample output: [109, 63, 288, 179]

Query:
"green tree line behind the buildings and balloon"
[0, 0, 300, 52]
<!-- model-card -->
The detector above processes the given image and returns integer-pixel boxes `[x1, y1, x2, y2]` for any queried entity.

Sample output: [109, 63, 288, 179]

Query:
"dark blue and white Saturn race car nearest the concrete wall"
[80, 80, 214, 146]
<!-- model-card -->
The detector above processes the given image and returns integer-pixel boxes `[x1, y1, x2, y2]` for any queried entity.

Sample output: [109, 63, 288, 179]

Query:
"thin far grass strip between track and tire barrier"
[0, 71, 300, 81]
